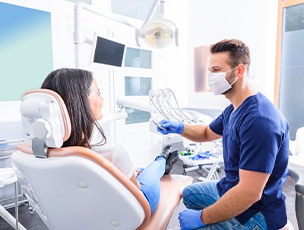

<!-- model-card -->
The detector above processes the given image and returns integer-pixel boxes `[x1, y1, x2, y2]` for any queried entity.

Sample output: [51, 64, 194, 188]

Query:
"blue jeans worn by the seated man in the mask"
[182, 181, 267, 230]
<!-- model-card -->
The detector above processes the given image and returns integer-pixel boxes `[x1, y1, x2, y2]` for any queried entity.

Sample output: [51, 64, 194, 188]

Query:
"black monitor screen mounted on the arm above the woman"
[93, 36, 125, 67]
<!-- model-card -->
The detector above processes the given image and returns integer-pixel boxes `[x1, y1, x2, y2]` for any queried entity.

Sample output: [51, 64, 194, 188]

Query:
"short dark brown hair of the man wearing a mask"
[210, 39, 250, 71]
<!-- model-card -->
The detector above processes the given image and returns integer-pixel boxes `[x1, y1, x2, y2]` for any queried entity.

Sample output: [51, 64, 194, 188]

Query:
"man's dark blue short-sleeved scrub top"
[210, 93, 289, 229]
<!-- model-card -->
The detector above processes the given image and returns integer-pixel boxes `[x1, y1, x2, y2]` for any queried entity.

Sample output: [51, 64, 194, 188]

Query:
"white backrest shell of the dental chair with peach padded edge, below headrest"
[12, 145, 150, 230]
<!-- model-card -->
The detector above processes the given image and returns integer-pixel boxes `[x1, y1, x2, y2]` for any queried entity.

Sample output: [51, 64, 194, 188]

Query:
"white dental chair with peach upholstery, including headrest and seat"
[12, 89, 192, 230]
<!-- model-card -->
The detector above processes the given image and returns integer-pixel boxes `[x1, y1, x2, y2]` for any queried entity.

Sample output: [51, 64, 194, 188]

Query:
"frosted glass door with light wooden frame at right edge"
[276, 0, 304, 139]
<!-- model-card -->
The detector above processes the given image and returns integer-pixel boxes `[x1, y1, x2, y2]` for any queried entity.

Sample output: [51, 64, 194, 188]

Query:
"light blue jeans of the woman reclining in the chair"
[137, 156, 166, 214]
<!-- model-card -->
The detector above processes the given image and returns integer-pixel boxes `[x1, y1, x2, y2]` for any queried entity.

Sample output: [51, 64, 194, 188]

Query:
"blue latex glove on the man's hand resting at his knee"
[178, 209, 205, 230]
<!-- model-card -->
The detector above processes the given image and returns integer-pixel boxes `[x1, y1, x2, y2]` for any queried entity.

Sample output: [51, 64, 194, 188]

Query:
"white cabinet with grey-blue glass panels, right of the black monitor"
[114, 47, 159, 167]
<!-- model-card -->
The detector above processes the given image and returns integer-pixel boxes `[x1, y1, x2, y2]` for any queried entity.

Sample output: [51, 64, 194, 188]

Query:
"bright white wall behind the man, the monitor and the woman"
[0, 0, 277, 158]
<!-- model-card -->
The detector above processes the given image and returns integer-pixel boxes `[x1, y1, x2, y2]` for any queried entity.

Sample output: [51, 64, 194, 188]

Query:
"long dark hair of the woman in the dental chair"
[41, 68, 106, 148]
